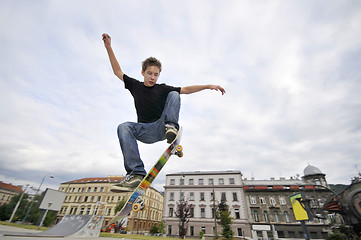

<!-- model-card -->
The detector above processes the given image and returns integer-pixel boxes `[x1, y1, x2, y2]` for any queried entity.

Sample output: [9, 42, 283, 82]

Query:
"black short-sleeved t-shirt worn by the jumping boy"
[123, 74, 181, 123]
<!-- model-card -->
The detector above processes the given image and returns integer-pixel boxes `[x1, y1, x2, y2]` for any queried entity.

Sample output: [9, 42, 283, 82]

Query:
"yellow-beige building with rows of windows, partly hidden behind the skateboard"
[57, 176, 163, 232]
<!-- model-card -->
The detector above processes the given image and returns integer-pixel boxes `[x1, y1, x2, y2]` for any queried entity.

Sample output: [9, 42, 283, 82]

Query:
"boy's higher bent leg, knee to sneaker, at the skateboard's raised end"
[161, 91, 181, 143]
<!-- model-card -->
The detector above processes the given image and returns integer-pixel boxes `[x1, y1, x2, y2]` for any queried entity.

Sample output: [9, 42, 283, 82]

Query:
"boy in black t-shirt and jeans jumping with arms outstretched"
[102, 33, 225, 192]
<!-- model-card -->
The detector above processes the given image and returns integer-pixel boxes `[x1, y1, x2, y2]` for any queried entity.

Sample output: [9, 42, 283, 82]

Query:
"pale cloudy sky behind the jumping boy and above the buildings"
[0, 0, 361, 190]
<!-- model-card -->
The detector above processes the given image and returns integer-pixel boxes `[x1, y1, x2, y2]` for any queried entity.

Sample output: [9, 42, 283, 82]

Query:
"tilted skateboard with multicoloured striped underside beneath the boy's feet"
[109, 127, 183, 228]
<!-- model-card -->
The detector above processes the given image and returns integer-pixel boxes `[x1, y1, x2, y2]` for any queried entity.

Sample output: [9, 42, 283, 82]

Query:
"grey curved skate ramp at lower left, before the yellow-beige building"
[4, 215, 103, 237]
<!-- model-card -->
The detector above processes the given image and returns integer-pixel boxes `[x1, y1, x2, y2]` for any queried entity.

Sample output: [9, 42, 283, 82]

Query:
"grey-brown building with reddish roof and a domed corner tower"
[243, 165, 335, 239]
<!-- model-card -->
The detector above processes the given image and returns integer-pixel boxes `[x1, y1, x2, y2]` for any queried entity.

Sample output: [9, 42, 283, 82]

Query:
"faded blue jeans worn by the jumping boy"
[118, 91, 180, 176]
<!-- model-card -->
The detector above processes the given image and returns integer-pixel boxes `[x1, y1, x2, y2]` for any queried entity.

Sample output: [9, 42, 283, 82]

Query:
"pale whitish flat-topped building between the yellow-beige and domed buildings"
[163, 171, 251, 238]
